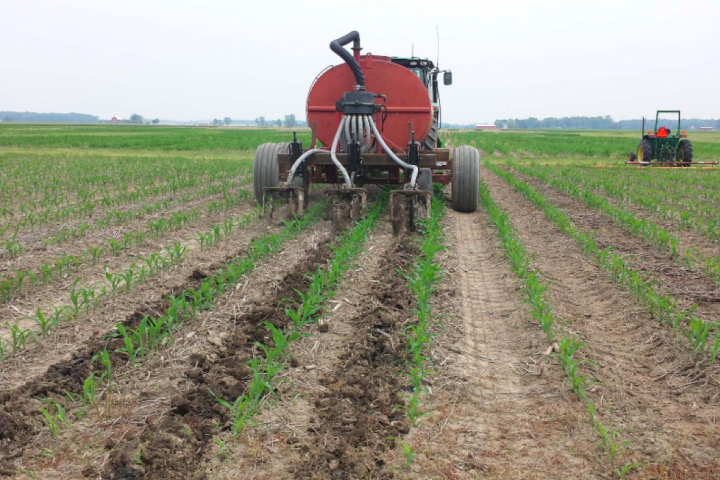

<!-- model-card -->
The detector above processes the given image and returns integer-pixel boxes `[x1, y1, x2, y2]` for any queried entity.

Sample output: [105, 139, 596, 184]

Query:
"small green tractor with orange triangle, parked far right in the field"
[628, 110, 692, 167]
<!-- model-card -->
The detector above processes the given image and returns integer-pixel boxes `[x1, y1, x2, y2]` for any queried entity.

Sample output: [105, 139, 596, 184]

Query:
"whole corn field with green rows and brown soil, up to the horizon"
[0, 123, 720, 480]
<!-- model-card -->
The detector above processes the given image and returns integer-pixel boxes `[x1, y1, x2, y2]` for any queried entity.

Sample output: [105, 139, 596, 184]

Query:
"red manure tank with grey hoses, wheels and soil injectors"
[253, 32, 480, 235]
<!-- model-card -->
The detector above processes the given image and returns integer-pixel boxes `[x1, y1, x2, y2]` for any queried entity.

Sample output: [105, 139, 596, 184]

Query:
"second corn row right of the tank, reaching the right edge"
[486, 163, 720, 365]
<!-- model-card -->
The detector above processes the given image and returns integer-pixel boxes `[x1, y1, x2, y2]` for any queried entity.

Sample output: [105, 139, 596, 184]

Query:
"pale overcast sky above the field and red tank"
[0, 0, 720, 123]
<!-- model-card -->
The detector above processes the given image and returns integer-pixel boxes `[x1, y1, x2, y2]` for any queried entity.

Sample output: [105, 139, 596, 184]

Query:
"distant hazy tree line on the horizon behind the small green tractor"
[495, 114, 720, 130]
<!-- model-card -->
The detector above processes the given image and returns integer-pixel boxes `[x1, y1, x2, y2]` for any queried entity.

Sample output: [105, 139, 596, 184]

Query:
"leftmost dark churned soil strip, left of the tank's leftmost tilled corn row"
[0, 211, 300, 475]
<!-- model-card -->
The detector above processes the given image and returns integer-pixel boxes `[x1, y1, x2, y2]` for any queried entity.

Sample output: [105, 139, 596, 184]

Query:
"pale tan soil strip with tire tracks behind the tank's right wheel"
[397, 211, 598, 479]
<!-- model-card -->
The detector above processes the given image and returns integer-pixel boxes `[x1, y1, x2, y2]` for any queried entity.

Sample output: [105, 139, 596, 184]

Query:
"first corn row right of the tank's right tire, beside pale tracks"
[480, 177, 629, 473]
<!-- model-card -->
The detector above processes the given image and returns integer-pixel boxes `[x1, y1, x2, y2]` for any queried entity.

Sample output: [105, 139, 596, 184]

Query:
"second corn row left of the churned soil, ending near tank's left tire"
[0, 194, 261, 302]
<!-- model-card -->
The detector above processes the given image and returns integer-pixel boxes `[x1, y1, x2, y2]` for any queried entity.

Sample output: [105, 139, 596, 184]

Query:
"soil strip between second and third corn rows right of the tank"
[505, 167, 720, 320]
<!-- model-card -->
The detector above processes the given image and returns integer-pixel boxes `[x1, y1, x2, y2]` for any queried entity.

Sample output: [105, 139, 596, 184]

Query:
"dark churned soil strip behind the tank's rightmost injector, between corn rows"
[288, 233, 417, 479]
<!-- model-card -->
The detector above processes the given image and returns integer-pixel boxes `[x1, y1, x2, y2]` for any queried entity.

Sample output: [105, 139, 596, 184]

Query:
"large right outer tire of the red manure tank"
[452, 145, 480, 213]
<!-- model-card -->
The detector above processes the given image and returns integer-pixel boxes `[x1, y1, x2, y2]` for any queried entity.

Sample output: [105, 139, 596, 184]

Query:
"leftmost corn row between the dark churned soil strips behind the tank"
[41, 203, 325, 433]
